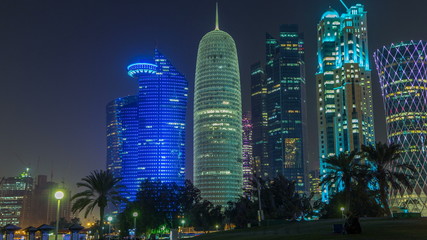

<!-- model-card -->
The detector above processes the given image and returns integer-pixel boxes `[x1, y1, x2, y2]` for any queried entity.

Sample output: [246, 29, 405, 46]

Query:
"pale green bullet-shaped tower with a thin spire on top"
[194, 6, 243, 207]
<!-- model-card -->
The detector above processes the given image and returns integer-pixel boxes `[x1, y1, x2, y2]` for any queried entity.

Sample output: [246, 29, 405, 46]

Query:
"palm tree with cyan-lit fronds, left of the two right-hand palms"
[320, 151, 366, 210]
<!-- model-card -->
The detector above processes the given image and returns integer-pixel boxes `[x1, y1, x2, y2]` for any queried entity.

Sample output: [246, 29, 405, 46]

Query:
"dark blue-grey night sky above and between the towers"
[0, 0, 427, 192]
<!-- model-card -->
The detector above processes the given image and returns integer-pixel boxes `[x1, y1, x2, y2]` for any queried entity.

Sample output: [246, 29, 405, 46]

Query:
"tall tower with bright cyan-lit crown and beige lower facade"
[316, 4, 375, 201]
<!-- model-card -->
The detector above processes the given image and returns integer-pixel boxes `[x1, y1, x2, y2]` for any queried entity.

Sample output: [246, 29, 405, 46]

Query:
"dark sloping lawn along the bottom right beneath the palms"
[193, 218, 427, 240]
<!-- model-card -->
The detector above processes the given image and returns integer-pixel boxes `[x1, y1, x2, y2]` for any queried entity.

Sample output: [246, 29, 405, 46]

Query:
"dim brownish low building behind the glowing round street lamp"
[21, 175, 71, 226]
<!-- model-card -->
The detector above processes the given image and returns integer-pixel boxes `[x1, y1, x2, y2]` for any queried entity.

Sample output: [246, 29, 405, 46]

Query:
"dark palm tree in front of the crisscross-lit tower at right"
[362, 142, 416, 216]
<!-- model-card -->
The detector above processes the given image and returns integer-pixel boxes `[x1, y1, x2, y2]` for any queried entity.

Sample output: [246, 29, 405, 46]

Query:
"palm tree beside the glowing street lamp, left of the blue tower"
[71, 170, 126, 239]
